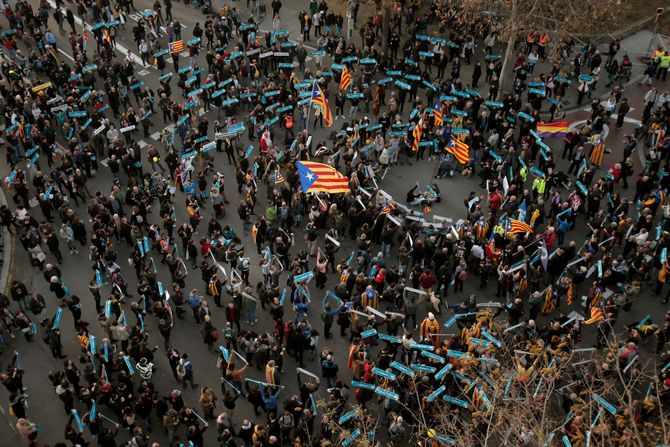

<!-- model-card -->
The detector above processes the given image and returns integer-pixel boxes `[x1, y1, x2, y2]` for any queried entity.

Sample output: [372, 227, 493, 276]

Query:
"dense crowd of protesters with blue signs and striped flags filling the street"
[0, 0, 670, 447]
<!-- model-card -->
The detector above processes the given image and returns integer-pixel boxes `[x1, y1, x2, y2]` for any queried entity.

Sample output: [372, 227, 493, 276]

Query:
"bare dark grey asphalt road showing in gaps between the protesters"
[0, 0, 666, 445]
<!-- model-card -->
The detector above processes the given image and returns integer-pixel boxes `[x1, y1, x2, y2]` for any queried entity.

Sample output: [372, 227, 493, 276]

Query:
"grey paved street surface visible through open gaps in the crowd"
[0, 0, 670, 445]
